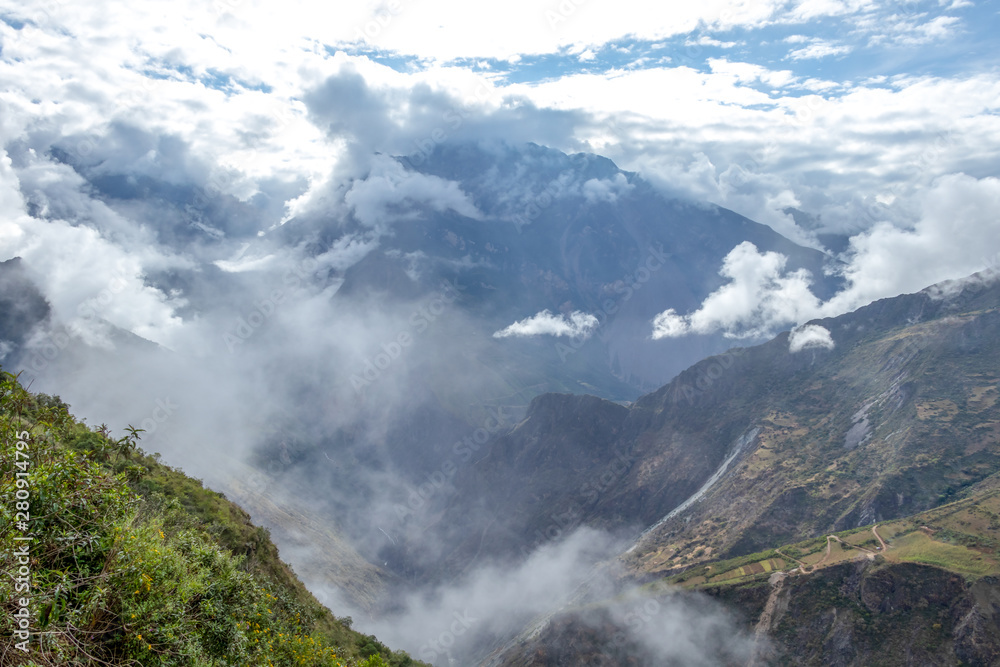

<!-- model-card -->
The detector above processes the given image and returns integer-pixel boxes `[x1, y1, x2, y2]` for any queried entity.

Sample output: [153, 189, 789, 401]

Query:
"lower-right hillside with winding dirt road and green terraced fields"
[490, 477, 1000, 667]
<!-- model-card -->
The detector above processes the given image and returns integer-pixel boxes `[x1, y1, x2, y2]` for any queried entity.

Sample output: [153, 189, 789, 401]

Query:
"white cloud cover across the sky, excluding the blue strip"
[0, 0, 1000, 360]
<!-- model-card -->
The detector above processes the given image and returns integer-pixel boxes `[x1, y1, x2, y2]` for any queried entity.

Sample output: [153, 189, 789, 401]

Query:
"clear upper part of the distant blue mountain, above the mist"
[306, 143, 840, 392]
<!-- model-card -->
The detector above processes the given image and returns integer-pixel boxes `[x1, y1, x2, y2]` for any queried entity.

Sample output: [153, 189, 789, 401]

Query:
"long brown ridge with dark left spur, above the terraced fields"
[407, 270, 1000, 584]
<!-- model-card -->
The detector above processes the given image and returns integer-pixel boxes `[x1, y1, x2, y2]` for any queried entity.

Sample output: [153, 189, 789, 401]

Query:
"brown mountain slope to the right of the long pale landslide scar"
[624, 272, 1000, 571]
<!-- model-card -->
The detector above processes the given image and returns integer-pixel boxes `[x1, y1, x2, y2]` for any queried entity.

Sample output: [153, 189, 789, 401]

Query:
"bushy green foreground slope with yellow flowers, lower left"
[0, 371, 420, 667]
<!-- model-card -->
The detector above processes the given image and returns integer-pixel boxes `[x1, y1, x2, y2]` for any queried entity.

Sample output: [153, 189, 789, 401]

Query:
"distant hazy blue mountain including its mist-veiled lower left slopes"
[248, 143, 839, 576]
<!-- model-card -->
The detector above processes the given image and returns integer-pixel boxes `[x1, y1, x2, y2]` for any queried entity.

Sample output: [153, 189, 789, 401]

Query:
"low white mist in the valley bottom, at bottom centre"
[359, 527, 751, 666]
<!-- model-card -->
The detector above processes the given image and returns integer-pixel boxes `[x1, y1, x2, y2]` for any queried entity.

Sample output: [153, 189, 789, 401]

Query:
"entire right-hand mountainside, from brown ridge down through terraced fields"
[468, 274, 1000, 665]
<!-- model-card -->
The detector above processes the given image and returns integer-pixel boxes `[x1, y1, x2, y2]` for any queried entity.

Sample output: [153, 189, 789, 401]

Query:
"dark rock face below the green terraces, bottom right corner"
[752, 561, 1000, 667]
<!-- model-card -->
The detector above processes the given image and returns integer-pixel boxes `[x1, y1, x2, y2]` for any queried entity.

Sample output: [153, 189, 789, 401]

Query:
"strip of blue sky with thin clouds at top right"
[350, 0, 1000, 88]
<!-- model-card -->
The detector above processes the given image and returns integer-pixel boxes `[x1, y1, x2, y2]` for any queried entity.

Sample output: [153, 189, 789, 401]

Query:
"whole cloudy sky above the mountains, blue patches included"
[0, 0, 1000, 354]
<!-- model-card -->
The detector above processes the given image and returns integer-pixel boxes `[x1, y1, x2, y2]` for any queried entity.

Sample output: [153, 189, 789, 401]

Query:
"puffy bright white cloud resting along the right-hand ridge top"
[652, 174, 1000, 349]
